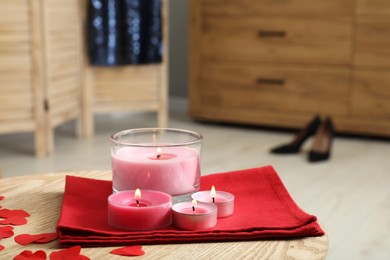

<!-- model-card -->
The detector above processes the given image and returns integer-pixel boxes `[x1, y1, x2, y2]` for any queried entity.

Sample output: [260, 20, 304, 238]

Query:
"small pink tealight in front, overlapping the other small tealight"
[172, 200, 217, 230]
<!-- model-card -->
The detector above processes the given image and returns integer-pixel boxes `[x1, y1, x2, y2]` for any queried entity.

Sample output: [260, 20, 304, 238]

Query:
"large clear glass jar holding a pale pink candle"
[111, 128, 203, 202]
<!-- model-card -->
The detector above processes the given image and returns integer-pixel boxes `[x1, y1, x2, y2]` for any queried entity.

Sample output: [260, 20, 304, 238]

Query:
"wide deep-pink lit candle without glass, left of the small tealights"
[108, 189, 172, 230]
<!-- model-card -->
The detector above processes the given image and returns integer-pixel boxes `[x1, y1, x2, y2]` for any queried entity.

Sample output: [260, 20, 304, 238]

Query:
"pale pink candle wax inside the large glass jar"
[112, 147, 200, 196]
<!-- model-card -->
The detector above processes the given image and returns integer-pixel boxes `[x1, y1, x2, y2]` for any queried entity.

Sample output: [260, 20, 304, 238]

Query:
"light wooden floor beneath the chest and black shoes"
[0, 98, 390, 260]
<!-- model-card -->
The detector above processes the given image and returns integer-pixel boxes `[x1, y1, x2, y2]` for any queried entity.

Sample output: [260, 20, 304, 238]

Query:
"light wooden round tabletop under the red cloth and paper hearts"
[0, 171, 328, 260]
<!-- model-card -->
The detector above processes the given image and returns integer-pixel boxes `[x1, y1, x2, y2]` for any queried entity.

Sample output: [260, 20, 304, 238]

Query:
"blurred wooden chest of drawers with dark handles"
[189, 0, 390, 136]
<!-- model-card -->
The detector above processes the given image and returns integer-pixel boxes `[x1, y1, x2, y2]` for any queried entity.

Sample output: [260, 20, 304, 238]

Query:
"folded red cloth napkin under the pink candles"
[57, 166, 324, 247]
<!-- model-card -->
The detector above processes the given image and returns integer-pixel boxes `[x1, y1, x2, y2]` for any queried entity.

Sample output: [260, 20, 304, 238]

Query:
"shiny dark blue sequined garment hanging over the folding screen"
[87, 0, 162, 66]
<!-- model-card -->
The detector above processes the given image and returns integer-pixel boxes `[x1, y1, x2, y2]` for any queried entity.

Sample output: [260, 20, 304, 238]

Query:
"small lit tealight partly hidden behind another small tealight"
[192, 186, 234, 218]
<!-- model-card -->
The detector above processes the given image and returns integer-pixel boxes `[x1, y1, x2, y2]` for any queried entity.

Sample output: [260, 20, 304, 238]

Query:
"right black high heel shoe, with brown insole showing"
[308, 117, 335, 162]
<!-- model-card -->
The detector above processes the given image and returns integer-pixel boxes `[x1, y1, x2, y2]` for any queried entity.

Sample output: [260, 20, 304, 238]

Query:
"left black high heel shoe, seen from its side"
[271, 116, 321, 154]
